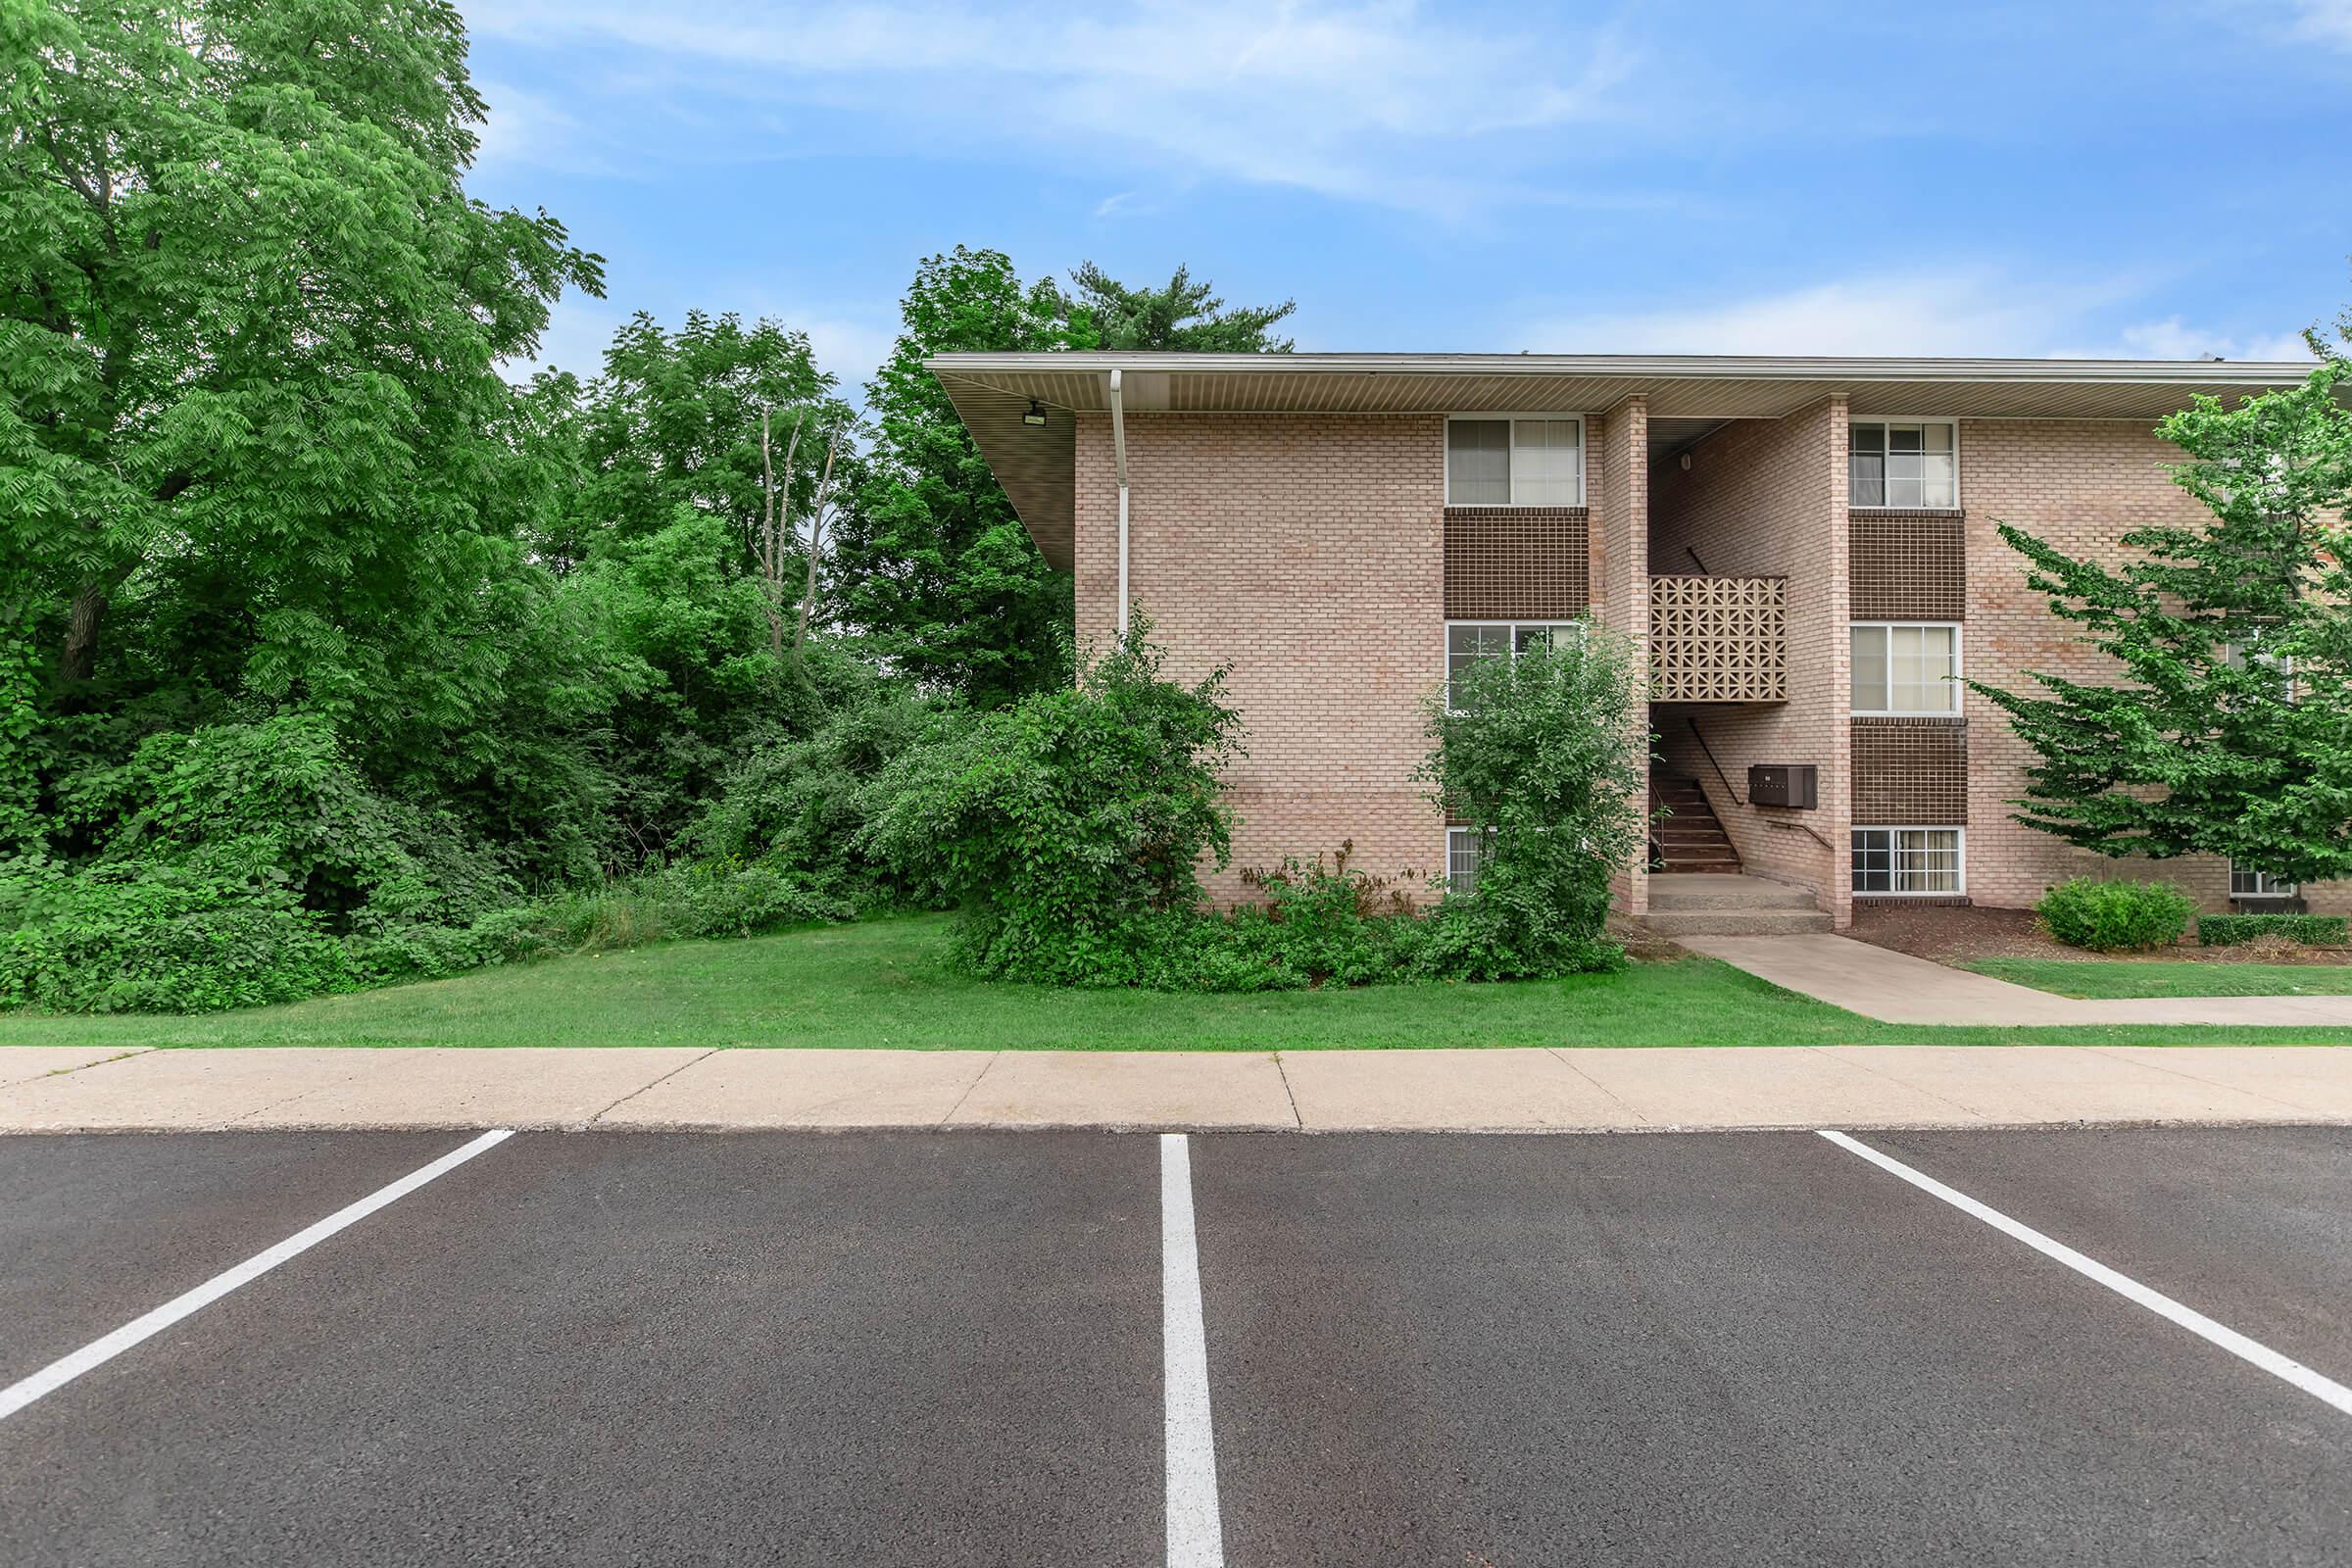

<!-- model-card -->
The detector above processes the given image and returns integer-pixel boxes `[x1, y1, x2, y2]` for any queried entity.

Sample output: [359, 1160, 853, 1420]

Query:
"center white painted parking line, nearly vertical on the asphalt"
[1159, 1133, 1225, 1568]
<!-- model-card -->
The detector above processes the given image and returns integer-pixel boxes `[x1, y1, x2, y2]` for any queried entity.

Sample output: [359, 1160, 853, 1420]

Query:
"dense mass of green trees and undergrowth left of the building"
[0, 0, 1289, 1010]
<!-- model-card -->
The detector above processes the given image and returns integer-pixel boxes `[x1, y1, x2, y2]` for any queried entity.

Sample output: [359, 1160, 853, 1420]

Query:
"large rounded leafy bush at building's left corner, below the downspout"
[863, 615, 1242, 985]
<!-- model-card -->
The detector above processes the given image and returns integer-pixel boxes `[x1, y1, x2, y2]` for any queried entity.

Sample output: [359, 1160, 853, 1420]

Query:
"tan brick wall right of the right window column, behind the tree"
[1959, 418, 2352, 912]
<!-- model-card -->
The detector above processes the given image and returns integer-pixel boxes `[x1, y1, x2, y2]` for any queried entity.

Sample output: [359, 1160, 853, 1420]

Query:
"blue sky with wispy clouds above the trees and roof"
[461, 0, 2352, 383]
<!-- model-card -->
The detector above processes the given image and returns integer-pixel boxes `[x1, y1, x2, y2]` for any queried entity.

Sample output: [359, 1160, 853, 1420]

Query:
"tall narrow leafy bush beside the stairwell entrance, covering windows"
[1418, 625, 1648, 980]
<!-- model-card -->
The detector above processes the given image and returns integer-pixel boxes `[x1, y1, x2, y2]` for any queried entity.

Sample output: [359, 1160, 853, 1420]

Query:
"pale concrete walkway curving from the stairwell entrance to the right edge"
[1675, 936, 2352, 1027]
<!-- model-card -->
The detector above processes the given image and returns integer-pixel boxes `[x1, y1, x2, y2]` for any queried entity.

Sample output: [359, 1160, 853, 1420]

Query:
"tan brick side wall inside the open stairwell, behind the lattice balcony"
[1648, 397, 1853, 926]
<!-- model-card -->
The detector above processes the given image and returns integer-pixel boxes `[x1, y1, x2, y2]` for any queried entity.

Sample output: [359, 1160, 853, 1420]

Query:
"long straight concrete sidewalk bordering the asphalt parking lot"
[0, 1046, 2352, 1133]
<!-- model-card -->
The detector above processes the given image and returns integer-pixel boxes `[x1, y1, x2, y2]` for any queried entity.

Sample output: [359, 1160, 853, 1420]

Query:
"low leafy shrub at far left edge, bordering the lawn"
[0, 860, 363, 1013]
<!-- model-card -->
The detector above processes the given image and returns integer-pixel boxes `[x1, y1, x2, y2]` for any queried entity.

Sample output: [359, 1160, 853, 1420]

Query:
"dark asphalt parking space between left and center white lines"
[0, 1133, 1162, 1566]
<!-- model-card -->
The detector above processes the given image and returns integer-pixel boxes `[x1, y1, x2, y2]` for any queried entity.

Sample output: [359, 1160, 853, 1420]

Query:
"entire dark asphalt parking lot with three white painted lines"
[0, 1126, 2352, 1568]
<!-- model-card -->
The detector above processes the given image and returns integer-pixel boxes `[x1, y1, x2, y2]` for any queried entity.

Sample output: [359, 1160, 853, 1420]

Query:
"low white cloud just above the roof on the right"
[1527, 268, 2310, 360]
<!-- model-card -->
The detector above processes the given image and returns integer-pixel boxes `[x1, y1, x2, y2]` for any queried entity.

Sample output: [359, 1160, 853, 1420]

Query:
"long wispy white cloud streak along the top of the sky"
[454, 0, 1640, 212]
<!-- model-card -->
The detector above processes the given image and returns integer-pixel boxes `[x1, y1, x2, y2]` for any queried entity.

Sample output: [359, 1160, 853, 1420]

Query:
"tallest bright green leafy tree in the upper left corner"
[0, 0, 600, 753]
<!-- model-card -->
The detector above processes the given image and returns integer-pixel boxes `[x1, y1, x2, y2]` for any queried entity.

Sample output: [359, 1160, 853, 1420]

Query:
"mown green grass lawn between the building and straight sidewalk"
[14, 917, 2352, 1051]
